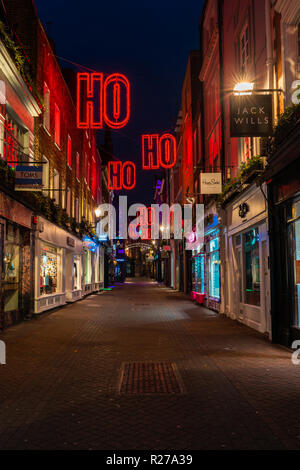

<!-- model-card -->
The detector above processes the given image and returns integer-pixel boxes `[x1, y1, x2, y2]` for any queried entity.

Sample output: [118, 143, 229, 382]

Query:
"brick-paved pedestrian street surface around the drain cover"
[0, 281, 300, 450]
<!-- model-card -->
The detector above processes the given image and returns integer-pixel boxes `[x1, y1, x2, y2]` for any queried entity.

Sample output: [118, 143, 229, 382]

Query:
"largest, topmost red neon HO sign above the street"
[77, 72, 130, 129]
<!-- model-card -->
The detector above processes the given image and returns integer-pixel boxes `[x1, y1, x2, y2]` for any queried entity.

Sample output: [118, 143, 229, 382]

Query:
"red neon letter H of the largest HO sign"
[77, 72, 103, 129]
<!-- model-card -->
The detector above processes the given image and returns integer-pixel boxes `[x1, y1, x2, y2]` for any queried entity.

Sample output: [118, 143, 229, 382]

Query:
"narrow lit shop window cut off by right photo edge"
[288, 201, 300, 328]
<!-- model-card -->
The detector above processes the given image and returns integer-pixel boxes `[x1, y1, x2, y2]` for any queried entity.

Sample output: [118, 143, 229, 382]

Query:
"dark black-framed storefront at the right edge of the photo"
[268, 151, 300, 347]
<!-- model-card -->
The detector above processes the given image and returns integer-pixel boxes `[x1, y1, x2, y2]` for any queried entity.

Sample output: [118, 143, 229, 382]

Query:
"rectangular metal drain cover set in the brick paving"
[119, 361, 184, 395]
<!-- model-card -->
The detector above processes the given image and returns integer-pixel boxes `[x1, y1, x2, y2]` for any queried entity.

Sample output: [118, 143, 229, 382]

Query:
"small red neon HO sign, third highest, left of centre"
[108, 161, 136, 191]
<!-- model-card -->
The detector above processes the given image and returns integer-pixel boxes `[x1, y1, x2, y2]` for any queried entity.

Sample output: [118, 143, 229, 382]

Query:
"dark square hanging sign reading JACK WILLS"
[230, 95, 273, 137]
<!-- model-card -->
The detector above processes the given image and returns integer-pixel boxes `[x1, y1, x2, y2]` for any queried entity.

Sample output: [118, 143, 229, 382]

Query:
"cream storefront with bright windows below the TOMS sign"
[34, 217, 83, 313]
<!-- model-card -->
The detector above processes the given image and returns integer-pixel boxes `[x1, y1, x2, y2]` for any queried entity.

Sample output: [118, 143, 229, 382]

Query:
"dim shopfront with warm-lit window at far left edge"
[0, 193, 33, 328]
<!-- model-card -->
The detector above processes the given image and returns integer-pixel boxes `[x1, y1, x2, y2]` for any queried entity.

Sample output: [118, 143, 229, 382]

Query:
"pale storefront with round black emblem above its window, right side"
[225, 185, 271, 334]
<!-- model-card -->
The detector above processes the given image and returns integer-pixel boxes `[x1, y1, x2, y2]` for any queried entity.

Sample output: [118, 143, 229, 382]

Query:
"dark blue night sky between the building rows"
[35, 0, 203, 204]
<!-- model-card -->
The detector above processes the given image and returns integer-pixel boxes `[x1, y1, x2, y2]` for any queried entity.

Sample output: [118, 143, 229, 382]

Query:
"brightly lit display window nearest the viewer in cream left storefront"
[40, 244, 61, 295]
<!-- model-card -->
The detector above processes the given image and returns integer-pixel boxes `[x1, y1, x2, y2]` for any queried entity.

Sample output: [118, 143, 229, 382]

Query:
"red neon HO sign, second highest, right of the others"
[142, 134, 177, 170]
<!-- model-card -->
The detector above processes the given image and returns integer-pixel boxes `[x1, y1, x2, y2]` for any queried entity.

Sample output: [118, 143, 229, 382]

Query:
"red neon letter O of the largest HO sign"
[103, 73, 130, 129]
